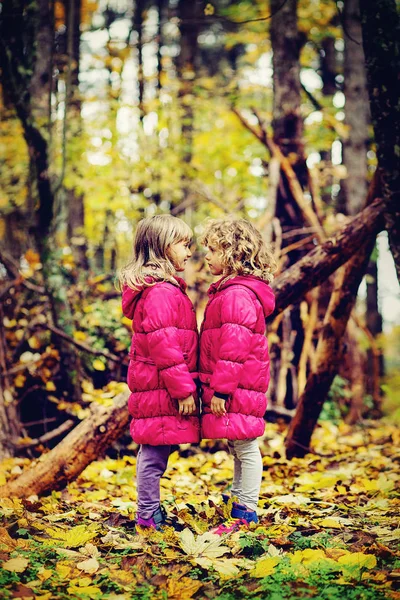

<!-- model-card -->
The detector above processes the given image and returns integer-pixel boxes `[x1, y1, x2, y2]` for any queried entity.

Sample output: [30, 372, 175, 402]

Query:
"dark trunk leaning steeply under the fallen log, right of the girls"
[285, 232, 375, 459]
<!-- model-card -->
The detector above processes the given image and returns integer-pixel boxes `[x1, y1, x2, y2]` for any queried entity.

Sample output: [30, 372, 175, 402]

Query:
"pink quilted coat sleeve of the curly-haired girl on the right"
[210, 287, 257, 394]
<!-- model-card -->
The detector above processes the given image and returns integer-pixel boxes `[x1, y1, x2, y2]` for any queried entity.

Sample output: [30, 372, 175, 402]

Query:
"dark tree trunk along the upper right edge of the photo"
[360, 0, 400, 281]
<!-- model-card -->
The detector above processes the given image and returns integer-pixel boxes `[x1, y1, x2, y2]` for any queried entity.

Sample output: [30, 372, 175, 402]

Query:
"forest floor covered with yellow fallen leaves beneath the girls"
[0, 421, 400, 600]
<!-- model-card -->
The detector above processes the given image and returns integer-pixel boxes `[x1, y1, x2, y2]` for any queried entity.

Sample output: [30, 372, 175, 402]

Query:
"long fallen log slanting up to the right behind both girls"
[0, 199, 383, 497]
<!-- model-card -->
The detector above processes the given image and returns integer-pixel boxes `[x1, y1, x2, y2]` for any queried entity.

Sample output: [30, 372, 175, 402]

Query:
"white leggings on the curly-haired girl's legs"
[228, 439, 263, 510]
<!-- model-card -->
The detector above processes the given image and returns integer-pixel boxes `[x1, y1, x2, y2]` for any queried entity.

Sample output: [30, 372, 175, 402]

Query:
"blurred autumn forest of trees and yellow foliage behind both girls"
[0, 0, 400, 596]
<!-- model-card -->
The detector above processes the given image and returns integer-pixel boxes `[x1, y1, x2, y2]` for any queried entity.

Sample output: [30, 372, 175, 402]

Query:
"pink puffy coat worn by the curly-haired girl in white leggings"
[199, 275, 275, 440]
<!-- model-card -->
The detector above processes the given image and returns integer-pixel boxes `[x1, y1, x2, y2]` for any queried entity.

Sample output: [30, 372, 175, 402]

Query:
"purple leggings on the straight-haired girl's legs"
[136, 444, 171, 519]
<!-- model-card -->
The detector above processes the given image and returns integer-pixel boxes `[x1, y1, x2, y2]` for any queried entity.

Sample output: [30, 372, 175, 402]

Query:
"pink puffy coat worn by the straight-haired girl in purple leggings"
[122, 277, 200, 446]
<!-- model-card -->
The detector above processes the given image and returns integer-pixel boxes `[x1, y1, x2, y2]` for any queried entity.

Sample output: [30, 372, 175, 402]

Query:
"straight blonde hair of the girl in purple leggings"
[118, 215, 193, 289]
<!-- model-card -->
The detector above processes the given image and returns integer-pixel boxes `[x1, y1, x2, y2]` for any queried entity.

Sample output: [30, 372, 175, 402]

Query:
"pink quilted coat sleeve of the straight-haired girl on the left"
[142, 284, 196, 400]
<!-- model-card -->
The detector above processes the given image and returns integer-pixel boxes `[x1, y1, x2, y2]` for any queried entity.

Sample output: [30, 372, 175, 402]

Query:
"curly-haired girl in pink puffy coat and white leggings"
[199, 219, 276, 535]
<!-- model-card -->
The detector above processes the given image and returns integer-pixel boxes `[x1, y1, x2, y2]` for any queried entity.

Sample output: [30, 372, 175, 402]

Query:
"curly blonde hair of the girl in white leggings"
[200, 219, 277, 283]
